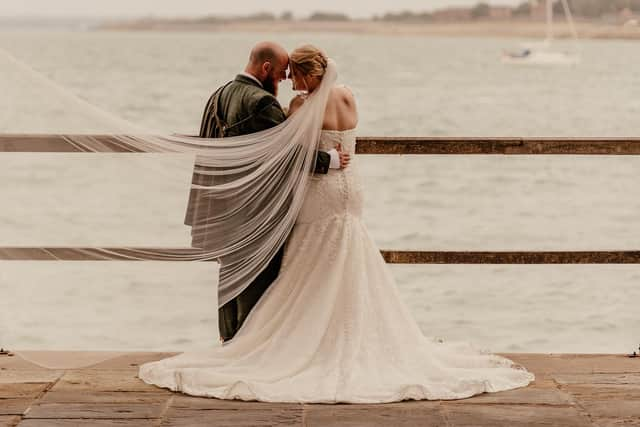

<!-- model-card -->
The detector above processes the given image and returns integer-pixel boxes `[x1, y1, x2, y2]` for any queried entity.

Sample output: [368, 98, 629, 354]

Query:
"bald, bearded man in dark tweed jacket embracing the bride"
[185, 42, 349, 341]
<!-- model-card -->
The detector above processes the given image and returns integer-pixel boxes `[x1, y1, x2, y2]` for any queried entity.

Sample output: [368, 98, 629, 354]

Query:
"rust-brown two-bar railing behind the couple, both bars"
[0, 135, 640, 264]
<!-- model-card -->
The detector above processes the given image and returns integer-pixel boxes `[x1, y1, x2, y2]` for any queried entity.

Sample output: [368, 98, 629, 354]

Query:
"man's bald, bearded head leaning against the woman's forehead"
[245, 41, 289, 95]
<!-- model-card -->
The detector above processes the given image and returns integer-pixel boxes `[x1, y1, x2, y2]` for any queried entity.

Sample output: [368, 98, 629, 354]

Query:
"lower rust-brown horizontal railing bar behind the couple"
[0, 247, 640, 264]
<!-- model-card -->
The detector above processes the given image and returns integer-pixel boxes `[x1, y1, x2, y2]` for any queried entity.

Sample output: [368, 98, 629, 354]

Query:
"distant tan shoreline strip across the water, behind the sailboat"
[96, 20, 640, 40]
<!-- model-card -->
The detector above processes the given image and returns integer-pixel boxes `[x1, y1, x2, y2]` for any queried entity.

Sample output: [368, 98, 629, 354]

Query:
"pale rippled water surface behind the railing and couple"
[0, 32, 640, 352]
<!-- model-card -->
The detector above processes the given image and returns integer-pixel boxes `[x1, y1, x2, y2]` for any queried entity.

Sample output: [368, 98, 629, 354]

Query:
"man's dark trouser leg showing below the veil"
[218, 245, 284, 341]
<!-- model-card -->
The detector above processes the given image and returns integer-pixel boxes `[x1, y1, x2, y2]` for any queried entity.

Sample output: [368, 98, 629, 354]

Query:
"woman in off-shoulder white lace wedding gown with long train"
[139, 46, 534, 403]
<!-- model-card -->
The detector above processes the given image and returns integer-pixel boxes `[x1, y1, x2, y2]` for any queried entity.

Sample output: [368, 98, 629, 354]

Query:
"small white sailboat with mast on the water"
[502, 0, 580, 65]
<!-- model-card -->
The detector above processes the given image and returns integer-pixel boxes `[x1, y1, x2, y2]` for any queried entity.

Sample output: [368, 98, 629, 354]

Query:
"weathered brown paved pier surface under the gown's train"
[0, 352, 640, 427]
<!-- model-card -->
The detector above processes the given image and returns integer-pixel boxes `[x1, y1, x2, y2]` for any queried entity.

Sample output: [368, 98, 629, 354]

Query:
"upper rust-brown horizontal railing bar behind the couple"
[0, 134, 640, 155]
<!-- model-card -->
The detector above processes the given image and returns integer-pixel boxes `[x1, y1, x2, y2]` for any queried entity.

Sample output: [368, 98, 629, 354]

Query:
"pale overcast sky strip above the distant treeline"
[0, 0, 522, 17]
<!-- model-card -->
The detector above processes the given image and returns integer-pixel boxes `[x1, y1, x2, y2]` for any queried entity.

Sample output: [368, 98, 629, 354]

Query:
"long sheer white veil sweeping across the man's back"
[0, 46, 337, 306]
